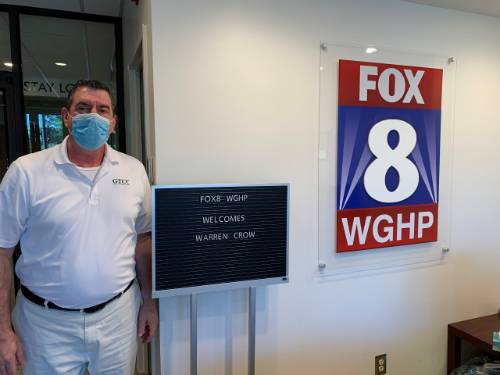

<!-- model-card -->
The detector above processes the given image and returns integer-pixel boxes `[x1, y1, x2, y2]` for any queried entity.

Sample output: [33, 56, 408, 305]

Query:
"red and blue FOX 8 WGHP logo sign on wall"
[336, 60, 443, 252]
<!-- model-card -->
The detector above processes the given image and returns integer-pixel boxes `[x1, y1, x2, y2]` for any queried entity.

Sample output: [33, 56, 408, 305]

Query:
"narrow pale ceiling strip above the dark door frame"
[0, 0, 123, 17]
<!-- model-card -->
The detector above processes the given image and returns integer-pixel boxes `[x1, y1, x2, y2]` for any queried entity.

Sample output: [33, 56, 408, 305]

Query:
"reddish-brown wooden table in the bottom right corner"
[447, 314, 500, 374]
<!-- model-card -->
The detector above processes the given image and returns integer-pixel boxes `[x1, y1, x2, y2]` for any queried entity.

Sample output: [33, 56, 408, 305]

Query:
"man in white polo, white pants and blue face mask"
[0, 81, 158, 375]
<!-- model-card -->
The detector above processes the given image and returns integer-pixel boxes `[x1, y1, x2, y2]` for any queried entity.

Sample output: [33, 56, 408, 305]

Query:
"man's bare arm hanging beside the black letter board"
[135, 233, 158, 343]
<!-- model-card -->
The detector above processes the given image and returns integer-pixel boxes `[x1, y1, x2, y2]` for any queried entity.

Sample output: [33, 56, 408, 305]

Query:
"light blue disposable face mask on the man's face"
[71, 113, 109, 151]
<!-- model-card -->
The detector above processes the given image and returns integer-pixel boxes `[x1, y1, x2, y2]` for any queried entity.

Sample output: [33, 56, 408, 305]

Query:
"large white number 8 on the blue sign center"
[364, 119, 419, 203]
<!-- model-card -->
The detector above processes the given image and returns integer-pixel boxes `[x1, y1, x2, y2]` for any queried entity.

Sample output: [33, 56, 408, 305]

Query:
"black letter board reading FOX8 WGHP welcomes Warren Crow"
[153, 184, 288, 297]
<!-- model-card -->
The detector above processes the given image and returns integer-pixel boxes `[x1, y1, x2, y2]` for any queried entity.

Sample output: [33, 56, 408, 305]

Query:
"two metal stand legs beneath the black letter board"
[190, 287, 257, 375]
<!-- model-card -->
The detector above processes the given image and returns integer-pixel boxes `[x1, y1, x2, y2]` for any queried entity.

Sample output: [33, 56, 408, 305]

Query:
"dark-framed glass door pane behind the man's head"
[20, 14, 119, 153]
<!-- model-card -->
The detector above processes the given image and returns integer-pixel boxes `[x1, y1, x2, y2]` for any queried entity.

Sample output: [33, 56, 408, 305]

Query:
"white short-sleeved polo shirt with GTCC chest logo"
[0, 138, 151, 308]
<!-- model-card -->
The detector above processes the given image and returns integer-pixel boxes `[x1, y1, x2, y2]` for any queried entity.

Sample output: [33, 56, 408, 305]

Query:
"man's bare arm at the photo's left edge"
[0, 247, 24, 375]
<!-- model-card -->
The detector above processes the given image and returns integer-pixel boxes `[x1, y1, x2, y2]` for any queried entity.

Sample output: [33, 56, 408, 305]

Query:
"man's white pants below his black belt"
[12, 282, 141, 375]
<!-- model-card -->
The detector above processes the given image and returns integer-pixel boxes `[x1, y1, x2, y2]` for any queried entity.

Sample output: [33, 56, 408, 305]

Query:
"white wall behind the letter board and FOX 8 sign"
[152, 0, 500, 375]
